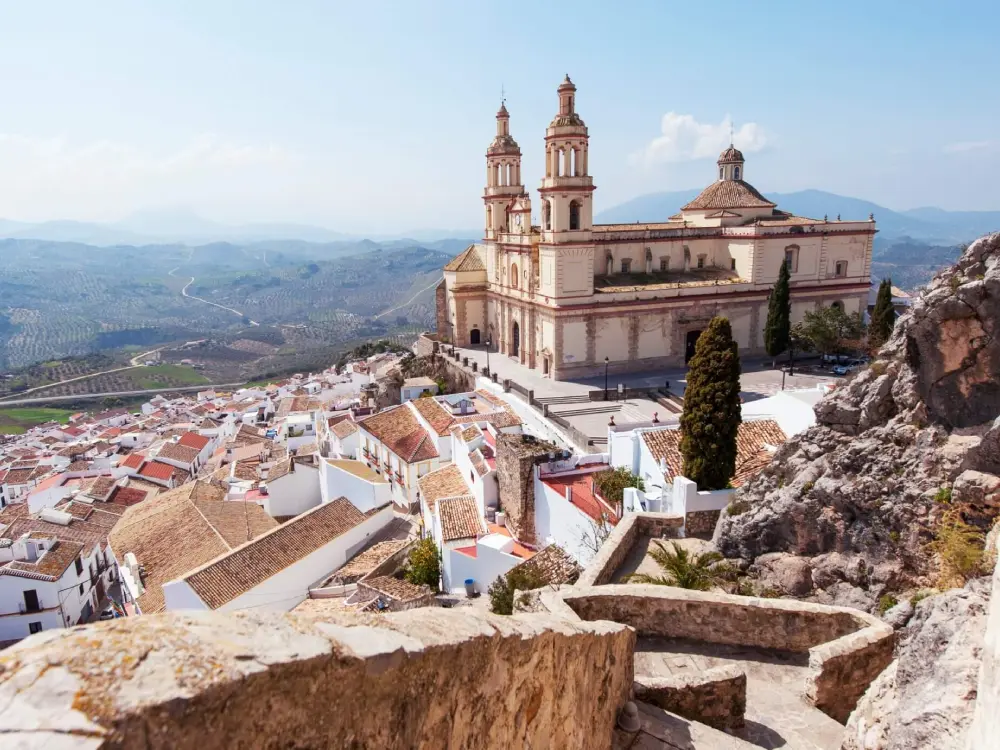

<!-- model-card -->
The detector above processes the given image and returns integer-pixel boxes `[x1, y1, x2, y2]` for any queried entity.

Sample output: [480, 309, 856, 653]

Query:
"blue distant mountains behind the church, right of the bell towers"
[594, 190, 1000, 244]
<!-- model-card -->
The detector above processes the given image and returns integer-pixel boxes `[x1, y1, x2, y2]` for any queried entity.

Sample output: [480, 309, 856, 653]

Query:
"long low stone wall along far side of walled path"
[563, 584, 872, 652]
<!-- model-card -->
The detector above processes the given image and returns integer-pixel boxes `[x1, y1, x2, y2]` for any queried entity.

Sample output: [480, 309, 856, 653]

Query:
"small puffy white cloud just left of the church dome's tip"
[632, 112, 768, 164]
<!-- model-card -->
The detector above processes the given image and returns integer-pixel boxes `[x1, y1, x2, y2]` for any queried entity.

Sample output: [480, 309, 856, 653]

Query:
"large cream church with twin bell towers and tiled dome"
[437, 76, 876, 379]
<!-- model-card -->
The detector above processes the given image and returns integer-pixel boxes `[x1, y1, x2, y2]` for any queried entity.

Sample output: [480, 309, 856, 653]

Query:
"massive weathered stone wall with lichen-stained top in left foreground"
[0, 608, 635, 750]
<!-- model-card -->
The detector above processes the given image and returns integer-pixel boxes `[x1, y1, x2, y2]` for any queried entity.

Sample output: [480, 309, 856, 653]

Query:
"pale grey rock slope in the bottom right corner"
[843, 579, 989, 750]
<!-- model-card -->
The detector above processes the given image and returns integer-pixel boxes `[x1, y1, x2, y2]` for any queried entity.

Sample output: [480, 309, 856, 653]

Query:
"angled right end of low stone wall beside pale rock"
[806, 628, 896, 723]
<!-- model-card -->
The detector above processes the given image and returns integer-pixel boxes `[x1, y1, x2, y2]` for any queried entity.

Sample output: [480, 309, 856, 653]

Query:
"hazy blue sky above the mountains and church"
[0, 0, 1000, 232]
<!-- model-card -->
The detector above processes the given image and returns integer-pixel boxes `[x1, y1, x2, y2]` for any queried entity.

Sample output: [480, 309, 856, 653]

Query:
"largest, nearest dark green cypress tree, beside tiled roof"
[681, 316, 743, 490]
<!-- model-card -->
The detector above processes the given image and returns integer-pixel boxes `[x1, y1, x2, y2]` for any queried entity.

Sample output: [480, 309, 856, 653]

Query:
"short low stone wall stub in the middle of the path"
[633, 664, 747, 732]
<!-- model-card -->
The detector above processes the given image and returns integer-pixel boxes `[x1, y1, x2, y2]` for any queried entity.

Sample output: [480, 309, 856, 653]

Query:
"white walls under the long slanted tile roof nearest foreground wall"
[163, 505, 393, 612]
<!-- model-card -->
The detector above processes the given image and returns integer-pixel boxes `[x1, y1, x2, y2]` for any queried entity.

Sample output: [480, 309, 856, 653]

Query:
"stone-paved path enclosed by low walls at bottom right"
[635, 637, 844, 750]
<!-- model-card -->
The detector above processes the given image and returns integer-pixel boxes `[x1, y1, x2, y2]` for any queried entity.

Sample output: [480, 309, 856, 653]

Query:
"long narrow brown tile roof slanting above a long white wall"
[184, 498, 366, 609]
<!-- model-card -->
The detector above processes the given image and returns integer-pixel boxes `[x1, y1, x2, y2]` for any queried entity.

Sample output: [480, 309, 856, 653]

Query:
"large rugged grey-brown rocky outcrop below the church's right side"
[714, 235, 1000, 610]
